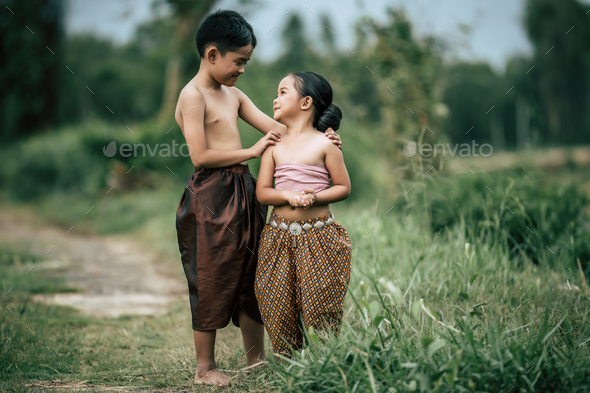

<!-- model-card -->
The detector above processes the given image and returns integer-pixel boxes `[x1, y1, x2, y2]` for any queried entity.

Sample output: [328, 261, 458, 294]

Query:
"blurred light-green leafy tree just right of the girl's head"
[359, 9, 446, 152]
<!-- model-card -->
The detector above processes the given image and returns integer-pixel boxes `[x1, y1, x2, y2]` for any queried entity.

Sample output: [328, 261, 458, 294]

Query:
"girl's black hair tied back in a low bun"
[289, 72, 342, 132]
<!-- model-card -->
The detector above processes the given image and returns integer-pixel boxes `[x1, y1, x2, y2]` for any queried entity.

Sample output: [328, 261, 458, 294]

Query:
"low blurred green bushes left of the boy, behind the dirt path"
[0, 122, 194, 201]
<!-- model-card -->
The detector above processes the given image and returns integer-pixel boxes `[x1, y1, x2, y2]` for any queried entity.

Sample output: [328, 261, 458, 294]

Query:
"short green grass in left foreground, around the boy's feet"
[0, 240, 269, 392]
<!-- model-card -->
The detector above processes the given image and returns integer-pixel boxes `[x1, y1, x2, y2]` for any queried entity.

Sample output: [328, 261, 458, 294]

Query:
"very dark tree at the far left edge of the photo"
[0, 0, 65, 141]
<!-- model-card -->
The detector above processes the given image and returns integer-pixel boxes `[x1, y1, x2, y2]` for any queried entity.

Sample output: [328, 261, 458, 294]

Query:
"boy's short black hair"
[195, 10, 256, 57]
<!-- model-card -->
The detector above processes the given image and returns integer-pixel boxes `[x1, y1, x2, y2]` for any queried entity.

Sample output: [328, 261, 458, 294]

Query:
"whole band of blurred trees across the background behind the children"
[0, 0, 590, 145]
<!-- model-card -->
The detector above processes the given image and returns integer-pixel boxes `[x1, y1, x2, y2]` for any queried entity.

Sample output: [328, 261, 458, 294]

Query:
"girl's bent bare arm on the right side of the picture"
[310, 139, 350, 206]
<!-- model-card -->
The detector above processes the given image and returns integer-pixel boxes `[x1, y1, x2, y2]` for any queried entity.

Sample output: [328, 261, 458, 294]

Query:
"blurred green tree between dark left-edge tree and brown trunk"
[59, 28, 171, 124]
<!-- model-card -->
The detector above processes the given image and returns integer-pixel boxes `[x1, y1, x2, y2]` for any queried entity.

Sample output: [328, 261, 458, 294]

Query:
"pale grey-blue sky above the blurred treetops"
[66, 0, 590, 71]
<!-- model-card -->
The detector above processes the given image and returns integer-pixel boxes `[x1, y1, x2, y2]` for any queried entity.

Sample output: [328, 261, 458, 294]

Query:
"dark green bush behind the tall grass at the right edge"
[399, 172, 590, 274]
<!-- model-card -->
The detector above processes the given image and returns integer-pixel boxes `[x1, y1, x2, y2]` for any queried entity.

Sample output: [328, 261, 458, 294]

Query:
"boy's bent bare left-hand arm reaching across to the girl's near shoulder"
[179, 91, 277, 168]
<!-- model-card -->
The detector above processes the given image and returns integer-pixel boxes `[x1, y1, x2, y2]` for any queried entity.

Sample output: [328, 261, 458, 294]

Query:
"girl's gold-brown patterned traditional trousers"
[254, 210, 352, 356]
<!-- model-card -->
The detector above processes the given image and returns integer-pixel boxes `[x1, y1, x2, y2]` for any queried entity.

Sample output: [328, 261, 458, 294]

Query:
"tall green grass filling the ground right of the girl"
[272, 204, 590, 392]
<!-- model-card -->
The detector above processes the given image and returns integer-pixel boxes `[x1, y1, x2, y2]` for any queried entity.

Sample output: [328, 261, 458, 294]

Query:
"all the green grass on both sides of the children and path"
[0, 171, 590, 392]
